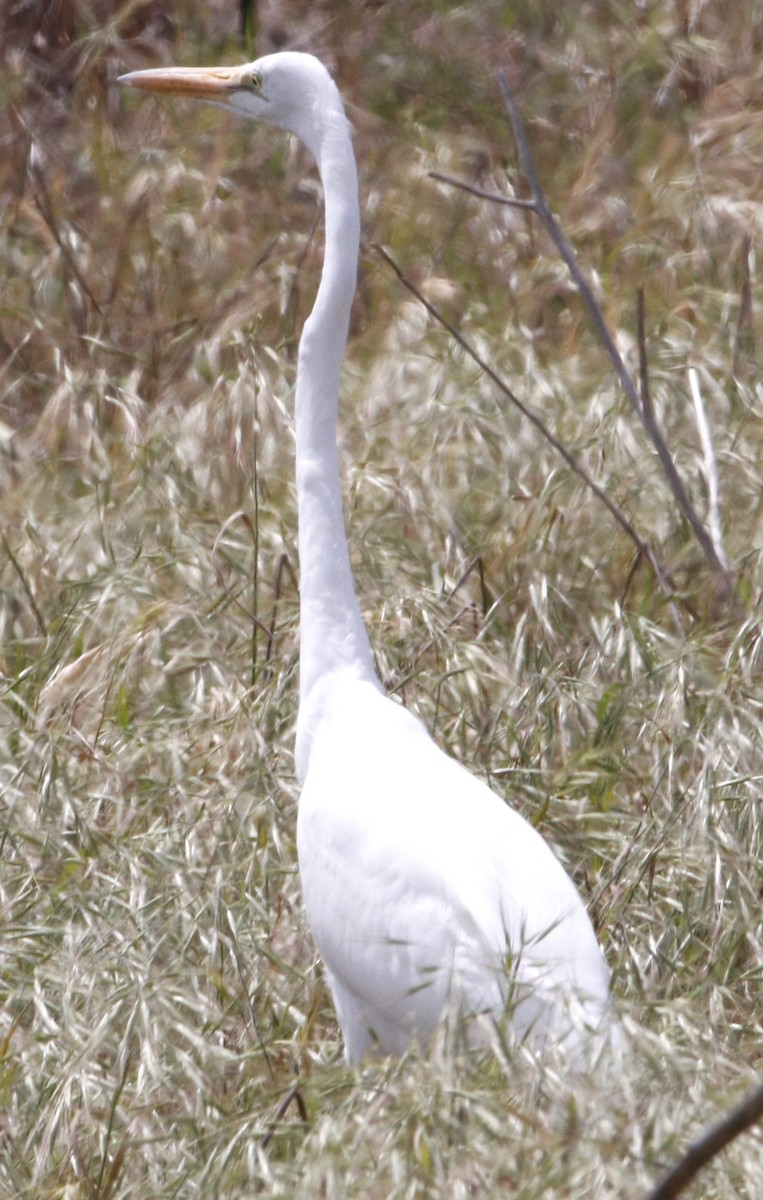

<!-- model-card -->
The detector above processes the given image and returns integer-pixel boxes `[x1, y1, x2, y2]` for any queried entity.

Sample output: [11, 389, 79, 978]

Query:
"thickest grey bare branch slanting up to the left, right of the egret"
[498, 71, 733, 595]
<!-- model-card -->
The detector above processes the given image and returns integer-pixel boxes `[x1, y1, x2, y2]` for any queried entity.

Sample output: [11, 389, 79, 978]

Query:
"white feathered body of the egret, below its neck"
[298, 680, 608, 1062]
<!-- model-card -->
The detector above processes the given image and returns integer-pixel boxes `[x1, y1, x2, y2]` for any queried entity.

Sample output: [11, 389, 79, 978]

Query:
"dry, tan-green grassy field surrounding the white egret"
[0, 0, 763, 1200]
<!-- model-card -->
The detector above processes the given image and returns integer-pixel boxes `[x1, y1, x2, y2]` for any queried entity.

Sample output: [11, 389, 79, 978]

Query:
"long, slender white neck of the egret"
[296, 94, 380, 779]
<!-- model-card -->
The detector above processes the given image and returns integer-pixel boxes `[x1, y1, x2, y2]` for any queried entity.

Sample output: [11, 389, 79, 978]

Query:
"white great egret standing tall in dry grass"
[121, 53, 609, 1064]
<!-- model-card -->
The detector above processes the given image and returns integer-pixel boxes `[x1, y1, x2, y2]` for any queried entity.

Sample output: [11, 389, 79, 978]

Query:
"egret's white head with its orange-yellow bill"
[119, 50, 342, 155]
